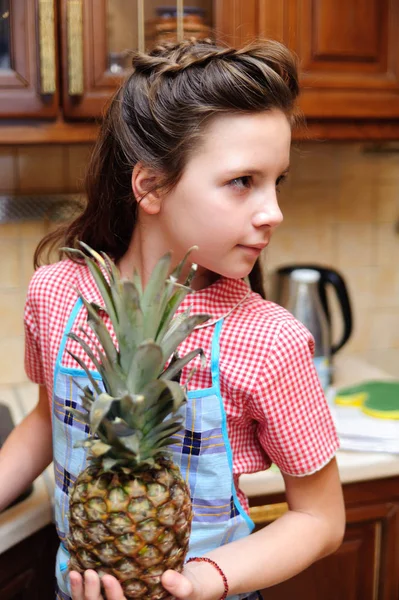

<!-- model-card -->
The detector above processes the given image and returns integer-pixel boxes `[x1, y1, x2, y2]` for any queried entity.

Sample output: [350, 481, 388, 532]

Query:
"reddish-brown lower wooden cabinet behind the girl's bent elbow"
[252, 478, 399, 600]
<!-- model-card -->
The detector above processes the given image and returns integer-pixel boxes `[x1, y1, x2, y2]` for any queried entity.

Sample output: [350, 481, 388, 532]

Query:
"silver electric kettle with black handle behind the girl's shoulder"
[273, 265, 352, 388]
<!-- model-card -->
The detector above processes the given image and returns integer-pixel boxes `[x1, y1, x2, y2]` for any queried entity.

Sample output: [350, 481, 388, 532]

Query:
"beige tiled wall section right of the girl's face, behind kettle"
[265, 143, 399, 377]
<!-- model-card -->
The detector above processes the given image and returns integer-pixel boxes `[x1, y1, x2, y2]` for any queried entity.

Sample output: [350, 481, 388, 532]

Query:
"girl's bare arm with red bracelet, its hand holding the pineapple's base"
[71, 459, 345, 600]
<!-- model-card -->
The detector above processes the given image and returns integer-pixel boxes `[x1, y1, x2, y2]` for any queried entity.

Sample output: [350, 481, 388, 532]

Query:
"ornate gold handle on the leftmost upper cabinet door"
[39, 0, 57, 95]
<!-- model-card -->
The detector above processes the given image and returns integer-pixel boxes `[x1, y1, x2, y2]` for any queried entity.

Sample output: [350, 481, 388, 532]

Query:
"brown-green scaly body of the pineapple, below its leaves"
[66, 458, 192, 600]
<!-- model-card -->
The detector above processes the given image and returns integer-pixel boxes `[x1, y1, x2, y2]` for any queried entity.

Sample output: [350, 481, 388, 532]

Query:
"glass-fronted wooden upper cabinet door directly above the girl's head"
[61, 0, 256, 119]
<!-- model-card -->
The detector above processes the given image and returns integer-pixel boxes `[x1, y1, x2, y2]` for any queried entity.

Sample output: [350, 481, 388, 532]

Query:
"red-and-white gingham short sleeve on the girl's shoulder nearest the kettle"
[252, 319, 339, 476]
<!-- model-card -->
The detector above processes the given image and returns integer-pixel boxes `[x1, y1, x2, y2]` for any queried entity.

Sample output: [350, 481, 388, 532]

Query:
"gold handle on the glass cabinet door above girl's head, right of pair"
[67, 0, 84, 96]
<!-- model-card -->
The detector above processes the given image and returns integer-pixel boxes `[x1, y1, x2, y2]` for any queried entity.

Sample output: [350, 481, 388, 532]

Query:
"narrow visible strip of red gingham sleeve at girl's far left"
[24, 271, 45, 385]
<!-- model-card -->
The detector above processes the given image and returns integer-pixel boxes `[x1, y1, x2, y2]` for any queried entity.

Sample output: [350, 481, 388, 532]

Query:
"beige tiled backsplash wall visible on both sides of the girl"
[0, 143, 399, 385]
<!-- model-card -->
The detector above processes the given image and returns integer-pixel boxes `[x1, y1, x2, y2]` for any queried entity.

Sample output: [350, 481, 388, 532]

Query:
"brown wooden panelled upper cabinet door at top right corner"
[259, 0, 399, 119]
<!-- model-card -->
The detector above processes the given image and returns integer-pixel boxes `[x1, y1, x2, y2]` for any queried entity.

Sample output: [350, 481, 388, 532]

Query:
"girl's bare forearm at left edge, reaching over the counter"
[0, 386, 52, 511]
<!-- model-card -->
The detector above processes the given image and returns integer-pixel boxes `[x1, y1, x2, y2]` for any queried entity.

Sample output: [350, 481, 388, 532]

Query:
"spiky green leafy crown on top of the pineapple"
[64, 242, 210, 470]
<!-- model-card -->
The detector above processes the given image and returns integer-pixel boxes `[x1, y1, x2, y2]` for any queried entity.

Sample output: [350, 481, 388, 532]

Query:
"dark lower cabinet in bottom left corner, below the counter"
[0, 525, 59, 600]
